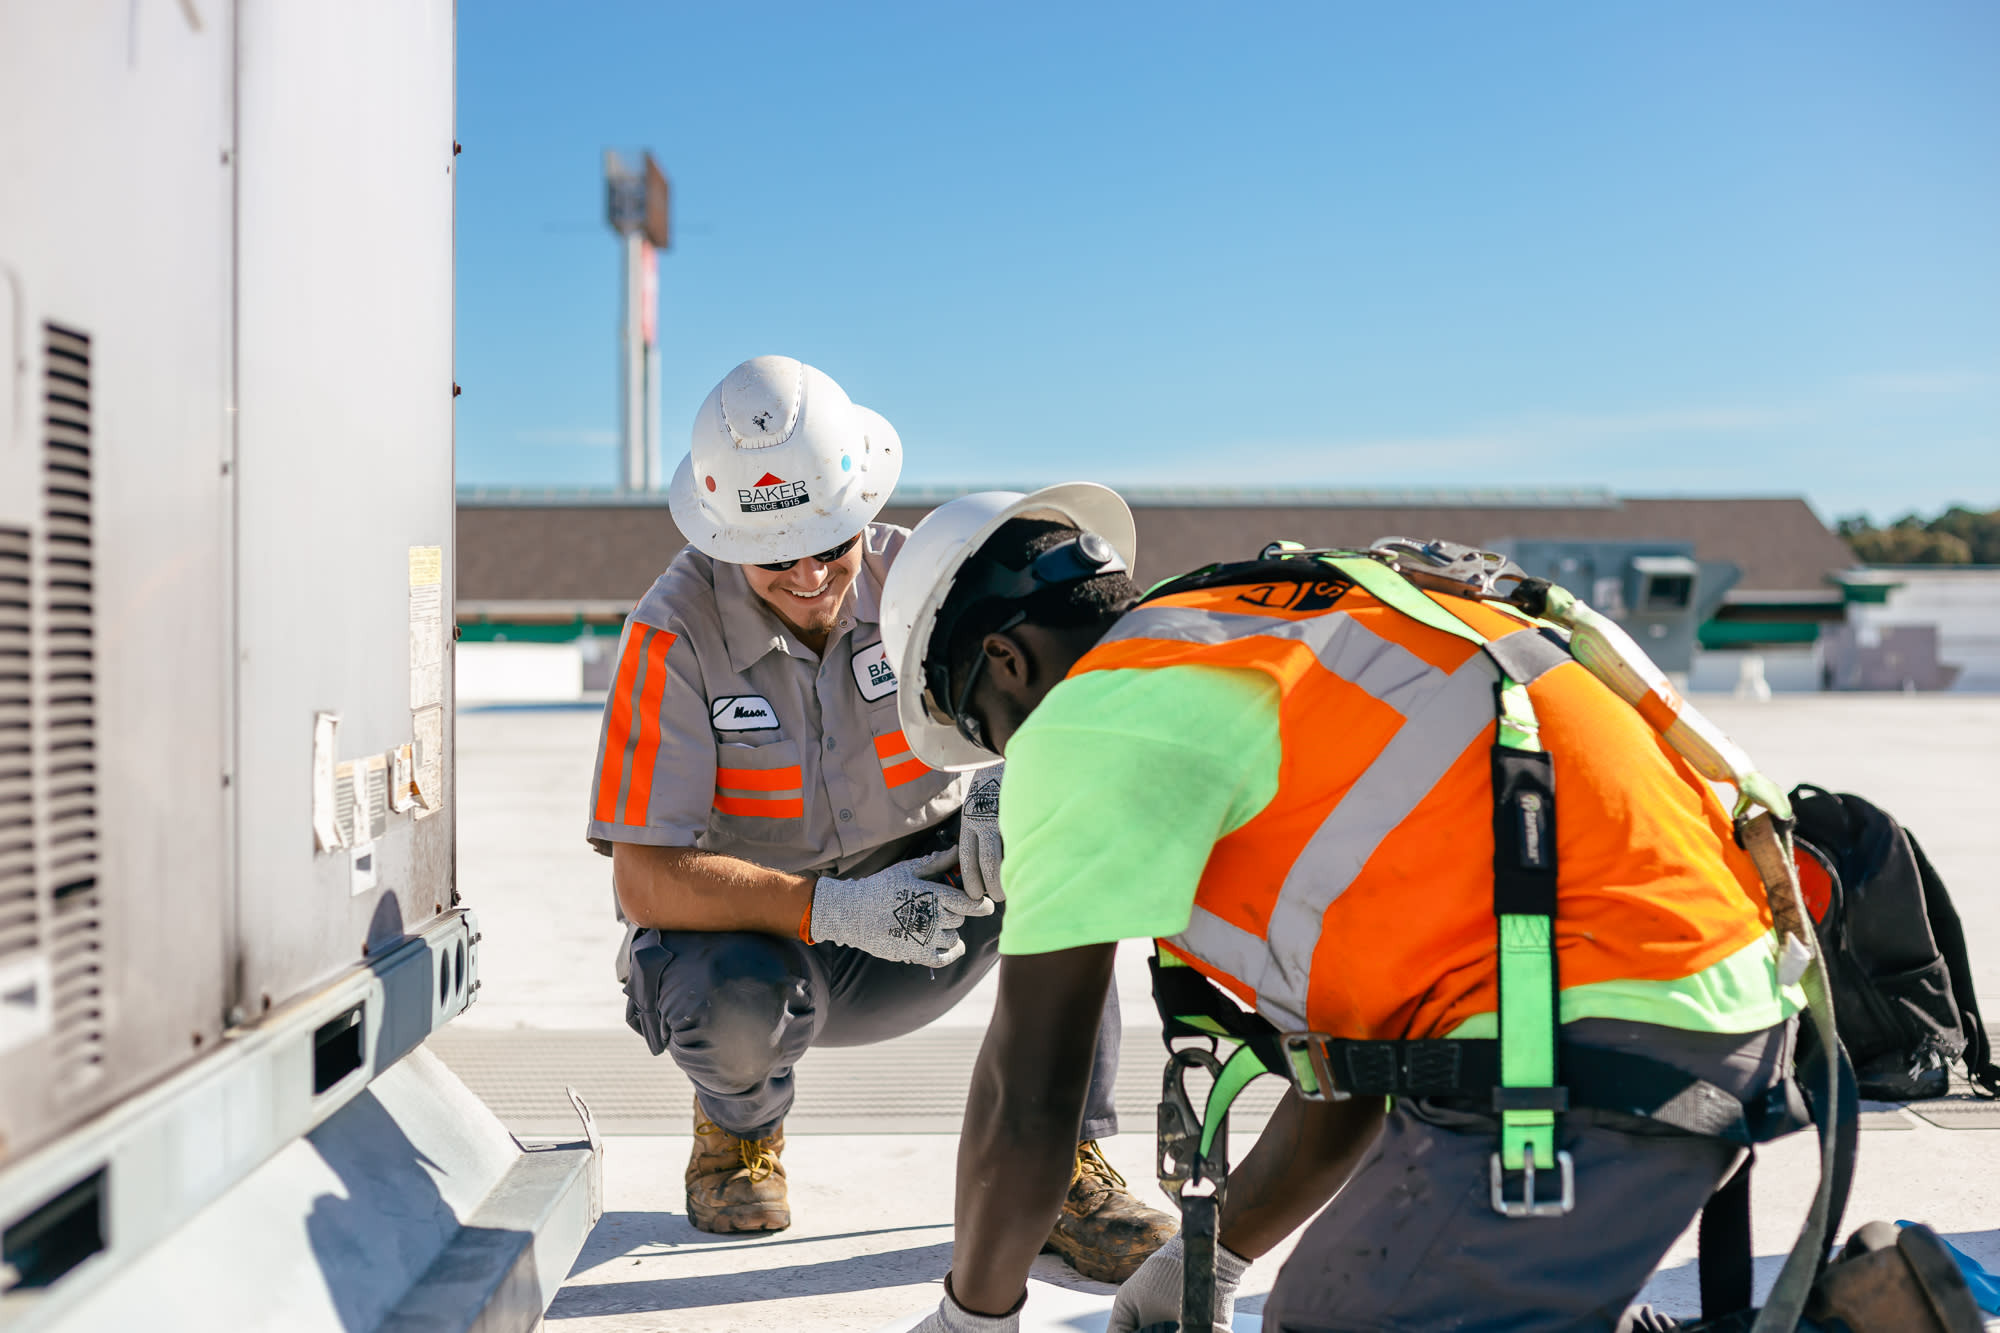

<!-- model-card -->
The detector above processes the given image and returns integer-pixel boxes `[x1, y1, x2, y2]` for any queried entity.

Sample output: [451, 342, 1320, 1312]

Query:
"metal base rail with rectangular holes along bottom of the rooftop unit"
[0, 909, 480, 1333]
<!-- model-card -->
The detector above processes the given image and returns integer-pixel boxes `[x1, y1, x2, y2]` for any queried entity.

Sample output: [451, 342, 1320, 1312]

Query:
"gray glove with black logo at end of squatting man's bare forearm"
[806, 847, 994, 967]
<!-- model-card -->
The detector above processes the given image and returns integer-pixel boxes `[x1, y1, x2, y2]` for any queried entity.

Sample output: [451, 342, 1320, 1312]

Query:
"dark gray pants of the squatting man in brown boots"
[626, 888, 1122, 1139]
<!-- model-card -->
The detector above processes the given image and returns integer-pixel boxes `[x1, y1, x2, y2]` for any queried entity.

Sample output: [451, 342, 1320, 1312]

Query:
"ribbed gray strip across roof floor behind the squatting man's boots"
[430, 1027, 1286, 1135]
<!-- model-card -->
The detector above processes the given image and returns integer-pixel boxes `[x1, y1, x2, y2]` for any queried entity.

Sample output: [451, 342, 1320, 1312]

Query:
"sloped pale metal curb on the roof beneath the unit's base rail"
[8, 1049, 602, 1333]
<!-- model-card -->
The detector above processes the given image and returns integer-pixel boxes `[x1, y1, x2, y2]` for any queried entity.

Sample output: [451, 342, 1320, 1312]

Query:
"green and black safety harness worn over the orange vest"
[1152, 542, 1856, 1329]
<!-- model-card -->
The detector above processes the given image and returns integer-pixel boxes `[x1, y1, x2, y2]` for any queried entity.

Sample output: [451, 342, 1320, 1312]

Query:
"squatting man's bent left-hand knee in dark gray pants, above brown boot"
[626, 931, 814, 1091]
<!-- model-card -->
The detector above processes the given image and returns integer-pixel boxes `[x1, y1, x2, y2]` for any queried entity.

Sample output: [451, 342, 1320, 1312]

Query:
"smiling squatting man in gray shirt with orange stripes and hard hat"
[588, 356, 1174, 1281]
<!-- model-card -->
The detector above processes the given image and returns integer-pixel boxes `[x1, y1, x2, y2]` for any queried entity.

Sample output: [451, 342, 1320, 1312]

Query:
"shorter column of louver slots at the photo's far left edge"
[0, 528, 30, 969]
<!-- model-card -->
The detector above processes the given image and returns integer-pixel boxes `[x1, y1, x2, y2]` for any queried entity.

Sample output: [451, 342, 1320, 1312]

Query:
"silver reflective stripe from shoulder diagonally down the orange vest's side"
[1128, 606, 1504, 1029]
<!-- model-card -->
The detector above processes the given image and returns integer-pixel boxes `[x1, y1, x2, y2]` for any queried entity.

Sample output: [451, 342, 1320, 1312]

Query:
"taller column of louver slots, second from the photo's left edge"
[36, 324, 104, 1093]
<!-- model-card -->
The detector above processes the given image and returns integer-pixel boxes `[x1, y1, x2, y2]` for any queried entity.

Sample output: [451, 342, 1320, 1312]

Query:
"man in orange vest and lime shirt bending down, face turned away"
[884, 484, 1796, 1333]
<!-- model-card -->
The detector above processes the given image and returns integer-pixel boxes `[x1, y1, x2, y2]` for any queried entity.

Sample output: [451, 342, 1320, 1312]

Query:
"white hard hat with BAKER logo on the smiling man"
[666, 356, 902, 564]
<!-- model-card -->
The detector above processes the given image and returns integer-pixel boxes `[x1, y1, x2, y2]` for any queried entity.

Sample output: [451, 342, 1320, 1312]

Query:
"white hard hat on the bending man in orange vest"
[882, 482, 1138, 773]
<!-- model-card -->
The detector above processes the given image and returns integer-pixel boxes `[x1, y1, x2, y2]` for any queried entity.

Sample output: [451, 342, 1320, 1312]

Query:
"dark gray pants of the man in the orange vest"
[1264, 1019, 1794, 1333]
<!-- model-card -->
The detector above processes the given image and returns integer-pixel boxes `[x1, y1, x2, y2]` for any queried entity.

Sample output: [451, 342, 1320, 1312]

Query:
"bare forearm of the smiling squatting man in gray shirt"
[612, 843, 818, 939]
